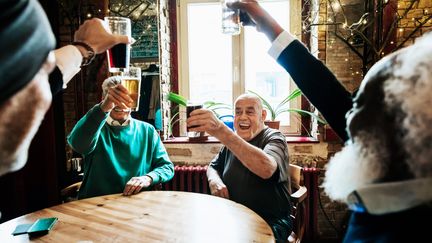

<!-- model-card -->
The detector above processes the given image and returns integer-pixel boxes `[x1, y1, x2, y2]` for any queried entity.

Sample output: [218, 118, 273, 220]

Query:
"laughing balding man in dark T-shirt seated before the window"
[187, 94, 292, 241]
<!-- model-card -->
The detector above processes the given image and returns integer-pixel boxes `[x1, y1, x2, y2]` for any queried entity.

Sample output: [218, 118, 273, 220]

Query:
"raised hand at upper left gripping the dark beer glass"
[74, 18, 134, 54]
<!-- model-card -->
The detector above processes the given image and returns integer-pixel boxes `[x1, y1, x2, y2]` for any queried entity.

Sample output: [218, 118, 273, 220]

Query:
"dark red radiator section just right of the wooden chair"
[303, 167, 320, 242]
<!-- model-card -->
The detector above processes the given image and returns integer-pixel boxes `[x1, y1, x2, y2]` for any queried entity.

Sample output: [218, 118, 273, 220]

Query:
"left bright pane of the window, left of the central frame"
[187, 2, 232, 104]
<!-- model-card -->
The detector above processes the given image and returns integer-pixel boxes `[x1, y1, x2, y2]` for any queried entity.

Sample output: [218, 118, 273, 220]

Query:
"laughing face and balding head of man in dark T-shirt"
[234, 95, 267, 141]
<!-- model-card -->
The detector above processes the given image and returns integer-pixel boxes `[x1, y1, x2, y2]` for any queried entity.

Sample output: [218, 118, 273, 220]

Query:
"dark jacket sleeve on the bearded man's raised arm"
[277, 40, 353, 141]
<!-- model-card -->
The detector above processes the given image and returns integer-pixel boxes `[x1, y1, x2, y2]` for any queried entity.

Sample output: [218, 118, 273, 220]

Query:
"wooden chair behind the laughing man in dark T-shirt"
[288, 164, 307, 243]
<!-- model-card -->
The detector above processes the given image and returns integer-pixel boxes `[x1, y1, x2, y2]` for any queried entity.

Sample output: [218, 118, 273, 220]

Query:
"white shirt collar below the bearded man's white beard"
[348, 177, 432, 215]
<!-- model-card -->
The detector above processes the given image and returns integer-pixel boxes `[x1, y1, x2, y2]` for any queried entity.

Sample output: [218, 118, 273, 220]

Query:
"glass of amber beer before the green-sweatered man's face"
[121, 67, 141, 111]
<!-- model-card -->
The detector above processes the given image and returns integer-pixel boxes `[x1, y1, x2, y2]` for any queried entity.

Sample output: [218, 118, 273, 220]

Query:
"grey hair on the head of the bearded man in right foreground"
[384, 33, 432, 178]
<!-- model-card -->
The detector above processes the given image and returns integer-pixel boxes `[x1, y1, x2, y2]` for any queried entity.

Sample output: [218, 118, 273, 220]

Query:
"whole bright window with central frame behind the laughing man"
[178, 0, 301, 134]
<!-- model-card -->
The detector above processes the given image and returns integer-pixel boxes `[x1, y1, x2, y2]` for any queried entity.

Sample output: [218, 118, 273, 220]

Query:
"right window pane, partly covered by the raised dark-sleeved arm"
[244, 0, 290, 126]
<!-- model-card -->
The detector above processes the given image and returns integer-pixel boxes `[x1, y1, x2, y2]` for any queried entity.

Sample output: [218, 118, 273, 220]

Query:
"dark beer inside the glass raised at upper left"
[108, 44, 130, 72]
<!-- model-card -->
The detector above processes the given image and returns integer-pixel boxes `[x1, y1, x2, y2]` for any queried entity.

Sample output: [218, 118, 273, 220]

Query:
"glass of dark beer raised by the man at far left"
[104, 16, 132, 72]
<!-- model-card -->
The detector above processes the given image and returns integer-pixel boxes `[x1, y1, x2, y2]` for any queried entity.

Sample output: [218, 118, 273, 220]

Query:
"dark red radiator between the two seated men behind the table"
[162, 165, 210, 194]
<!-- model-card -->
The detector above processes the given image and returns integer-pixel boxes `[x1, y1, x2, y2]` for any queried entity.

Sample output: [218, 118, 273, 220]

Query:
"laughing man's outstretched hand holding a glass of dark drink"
[187, 109, 225, 136]
